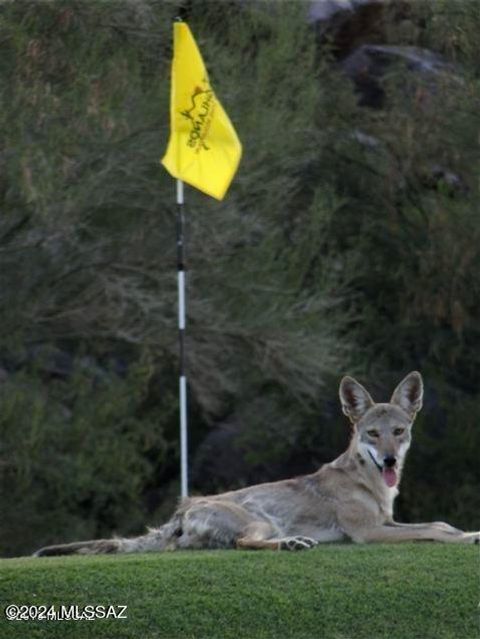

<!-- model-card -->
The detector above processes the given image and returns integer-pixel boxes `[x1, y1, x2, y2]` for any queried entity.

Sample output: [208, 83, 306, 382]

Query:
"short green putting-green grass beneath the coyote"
[0, 543, 480, 639]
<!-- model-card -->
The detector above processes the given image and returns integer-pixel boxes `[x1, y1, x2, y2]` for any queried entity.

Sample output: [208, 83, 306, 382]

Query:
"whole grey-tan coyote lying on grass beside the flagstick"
[35, 372, 480, 557]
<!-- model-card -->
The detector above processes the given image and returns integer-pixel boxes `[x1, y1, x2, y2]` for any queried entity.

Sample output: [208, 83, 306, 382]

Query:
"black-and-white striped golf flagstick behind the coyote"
[177, 180, 188, 497]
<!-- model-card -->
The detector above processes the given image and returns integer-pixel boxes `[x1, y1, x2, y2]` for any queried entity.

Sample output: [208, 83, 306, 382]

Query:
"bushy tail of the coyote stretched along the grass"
[33, 521, 177, 557]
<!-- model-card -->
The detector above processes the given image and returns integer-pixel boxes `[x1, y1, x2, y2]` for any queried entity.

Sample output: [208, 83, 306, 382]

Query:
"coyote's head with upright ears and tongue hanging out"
[340, 371, 423, 487]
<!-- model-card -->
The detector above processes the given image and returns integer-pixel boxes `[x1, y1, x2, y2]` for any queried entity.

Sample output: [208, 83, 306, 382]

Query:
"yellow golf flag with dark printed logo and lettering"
[162, 22, 242, 200]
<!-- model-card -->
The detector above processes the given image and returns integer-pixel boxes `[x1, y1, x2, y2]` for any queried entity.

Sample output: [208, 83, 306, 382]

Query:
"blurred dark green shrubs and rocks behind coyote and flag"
[0, 0, 480, 556]
